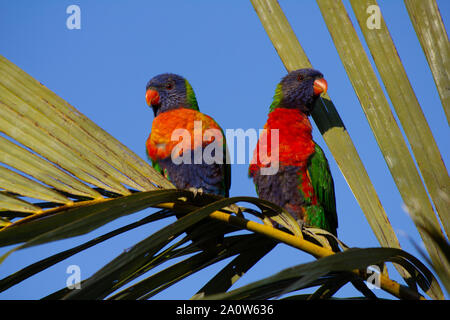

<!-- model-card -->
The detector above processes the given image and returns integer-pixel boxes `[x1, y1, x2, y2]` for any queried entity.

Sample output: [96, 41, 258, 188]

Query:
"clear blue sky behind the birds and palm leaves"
[0, 0, 450, 299]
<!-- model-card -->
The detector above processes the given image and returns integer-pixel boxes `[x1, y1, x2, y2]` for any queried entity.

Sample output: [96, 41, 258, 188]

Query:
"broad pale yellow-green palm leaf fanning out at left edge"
[0, 56, 173, 206]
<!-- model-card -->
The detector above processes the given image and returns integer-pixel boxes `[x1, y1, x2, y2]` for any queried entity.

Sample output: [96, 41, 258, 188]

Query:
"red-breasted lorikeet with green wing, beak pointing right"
[249, 69, 338, 235]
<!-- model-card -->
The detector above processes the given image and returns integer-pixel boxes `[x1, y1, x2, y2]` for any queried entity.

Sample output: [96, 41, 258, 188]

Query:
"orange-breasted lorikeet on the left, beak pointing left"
[146, 73, 231, 197]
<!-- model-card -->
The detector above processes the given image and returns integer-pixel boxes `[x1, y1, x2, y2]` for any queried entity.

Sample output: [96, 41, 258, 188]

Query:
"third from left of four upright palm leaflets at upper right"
[351, 0, 450, 240]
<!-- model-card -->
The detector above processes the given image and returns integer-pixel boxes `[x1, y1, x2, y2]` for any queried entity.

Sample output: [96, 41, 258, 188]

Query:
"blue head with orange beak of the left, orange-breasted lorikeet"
[145, 73, 198, 117]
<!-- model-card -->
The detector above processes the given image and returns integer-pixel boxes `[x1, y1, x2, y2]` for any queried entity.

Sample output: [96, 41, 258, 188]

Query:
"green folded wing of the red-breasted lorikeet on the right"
[308, 143, 338, 234]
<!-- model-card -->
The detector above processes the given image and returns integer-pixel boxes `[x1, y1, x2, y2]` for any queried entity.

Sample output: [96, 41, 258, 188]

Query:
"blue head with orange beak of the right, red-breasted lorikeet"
[271, 69, 327, 115]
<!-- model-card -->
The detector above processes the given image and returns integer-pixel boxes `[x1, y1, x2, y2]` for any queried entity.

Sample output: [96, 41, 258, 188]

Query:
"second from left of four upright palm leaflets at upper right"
[317, 0, 450, 282]
